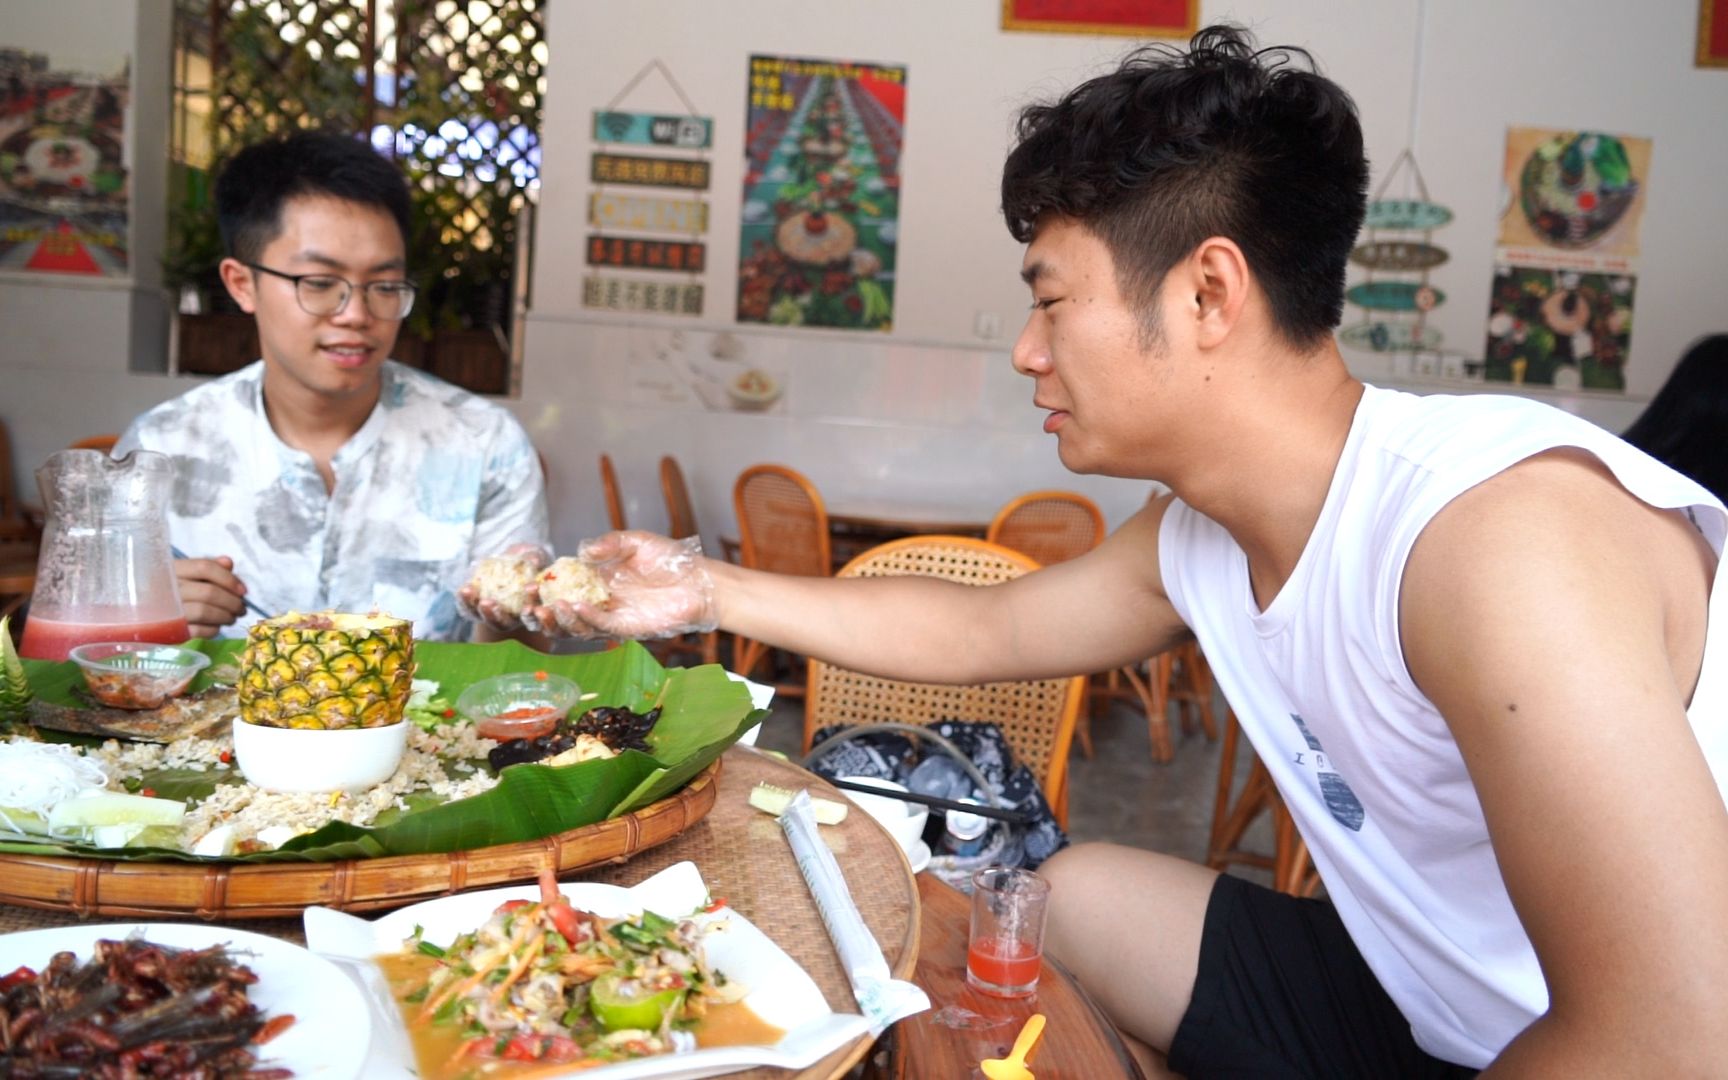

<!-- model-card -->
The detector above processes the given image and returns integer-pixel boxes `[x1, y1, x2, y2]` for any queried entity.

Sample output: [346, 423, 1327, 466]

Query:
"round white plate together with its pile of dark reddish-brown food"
[0, 923, 372, 1080]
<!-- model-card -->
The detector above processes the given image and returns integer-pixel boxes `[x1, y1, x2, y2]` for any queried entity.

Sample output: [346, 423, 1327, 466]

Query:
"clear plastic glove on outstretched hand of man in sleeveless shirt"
[522, 530, 721, 639]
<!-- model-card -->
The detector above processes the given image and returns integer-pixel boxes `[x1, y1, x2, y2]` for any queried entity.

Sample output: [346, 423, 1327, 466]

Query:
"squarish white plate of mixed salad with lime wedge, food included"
[306, 862, 869, 1080]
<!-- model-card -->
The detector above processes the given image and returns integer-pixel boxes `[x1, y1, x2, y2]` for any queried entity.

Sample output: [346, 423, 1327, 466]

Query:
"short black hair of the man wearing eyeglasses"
[216, 131, 408, 263]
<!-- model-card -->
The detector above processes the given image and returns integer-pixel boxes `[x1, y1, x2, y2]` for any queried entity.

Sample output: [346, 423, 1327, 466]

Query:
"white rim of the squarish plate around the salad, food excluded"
[306, 862, 869, 1080]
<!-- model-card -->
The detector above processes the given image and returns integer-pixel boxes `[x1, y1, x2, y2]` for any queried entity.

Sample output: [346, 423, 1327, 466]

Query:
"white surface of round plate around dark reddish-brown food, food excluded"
[0, 923, 372, 1080]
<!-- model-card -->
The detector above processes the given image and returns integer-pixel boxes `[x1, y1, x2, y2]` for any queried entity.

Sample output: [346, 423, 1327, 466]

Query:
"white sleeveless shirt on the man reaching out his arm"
[1159, 387, 1728, 1068]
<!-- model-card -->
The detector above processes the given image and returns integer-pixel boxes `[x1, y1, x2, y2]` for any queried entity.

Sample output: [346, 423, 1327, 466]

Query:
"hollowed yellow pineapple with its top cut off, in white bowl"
[238, 612, 415, 729]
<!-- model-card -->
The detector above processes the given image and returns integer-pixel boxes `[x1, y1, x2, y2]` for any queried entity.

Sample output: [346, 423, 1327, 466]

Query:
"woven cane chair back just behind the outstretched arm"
[804, 536, 1085, 826]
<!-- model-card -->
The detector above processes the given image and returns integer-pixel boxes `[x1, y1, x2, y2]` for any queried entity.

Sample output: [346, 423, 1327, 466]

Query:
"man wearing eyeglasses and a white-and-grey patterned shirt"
[116, 133, 548, 639]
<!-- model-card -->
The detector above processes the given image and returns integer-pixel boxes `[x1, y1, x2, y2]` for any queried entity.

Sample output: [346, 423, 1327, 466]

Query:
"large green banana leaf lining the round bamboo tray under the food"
[0, 641, 767, 862]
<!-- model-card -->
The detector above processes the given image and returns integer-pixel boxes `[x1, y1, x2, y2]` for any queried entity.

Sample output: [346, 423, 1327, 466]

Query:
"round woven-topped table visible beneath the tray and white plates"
[0, 746, 919, 1080]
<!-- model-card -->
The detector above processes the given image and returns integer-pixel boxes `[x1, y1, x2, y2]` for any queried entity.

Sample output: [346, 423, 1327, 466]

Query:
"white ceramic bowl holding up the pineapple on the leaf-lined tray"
[233, 719, 408, 791]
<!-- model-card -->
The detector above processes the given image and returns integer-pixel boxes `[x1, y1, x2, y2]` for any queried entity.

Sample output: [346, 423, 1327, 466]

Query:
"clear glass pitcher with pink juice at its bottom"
[19, 449, 188, 660]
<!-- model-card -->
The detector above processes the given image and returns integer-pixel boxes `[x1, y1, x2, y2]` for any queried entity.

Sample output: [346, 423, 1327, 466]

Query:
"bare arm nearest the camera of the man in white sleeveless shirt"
[1400, 453, 1728, 1077]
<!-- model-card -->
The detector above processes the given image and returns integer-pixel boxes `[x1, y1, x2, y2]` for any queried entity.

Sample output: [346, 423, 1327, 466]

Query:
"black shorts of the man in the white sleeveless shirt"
[1170, 874, 1476, 1080]
